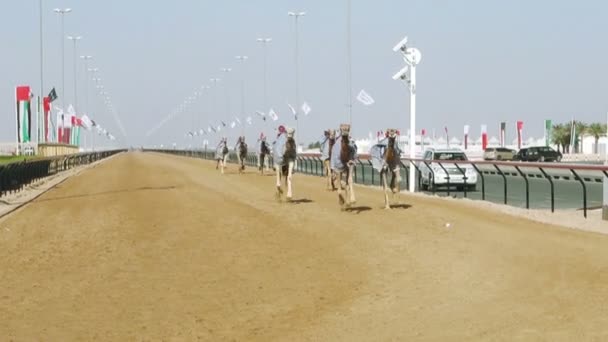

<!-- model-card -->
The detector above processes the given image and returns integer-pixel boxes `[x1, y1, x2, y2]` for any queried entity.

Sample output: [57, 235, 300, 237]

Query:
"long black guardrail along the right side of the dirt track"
[148, 150, 608, 217]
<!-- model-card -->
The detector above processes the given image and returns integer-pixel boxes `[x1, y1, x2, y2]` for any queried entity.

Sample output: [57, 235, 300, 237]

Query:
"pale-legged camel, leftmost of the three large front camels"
[274, 126, 297, 202]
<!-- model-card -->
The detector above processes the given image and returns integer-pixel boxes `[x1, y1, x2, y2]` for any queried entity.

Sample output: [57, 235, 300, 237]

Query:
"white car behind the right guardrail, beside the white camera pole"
[419, 148, 477, 191]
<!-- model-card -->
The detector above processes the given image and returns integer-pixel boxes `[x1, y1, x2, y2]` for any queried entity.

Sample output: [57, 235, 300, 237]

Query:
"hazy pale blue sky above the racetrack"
[0, 0, 608, 146]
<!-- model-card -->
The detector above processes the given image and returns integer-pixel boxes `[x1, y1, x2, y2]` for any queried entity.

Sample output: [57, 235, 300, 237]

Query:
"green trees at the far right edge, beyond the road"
[551, 121, 606, 154]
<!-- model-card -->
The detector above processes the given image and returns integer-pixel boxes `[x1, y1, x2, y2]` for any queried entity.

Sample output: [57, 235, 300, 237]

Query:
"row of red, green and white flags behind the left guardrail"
[15, 86, 116, 146]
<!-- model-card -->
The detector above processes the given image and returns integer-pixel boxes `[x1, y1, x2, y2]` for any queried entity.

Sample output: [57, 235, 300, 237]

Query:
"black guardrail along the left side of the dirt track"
[0, 150, 125, 198]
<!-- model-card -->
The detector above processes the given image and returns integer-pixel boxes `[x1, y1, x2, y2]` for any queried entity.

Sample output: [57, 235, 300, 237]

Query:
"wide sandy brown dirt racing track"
[0, 153, 608, 341]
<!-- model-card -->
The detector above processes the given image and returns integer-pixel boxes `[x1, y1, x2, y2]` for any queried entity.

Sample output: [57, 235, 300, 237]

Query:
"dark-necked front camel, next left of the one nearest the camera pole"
[331, 124, 357, 210]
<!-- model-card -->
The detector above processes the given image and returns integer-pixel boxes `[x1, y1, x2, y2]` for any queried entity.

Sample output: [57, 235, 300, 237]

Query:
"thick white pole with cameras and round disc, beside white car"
[393, 37, 422, 192]
